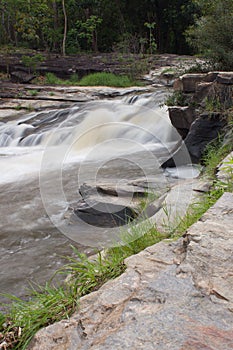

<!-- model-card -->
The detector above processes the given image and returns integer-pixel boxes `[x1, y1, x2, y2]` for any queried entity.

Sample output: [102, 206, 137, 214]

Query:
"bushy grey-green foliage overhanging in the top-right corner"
[186, 0, 233, 70]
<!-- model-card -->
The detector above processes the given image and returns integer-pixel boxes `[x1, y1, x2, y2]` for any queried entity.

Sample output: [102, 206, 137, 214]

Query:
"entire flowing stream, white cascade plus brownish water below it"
[0, 91, 193, 302]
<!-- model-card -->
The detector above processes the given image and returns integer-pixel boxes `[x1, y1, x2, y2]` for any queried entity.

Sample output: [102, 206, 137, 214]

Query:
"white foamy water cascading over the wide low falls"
[0, 94, 179, 183]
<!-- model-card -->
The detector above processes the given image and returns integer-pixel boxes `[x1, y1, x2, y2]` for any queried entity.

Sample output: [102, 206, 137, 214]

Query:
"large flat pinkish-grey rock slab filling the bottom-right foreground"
[29, 193, 233, 350]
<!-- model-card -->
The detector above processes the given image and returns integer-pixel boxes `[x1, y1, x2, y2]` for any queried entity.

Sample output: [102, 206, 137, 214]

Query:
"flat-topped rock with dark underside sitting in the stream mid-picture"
[65, 183, 148, 227]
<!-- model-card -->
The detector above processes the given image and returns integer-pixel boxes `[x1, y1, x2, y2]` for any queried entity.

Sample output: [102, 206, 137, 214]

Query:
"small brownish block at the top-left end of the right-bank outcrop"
[173, 73, 207, 93]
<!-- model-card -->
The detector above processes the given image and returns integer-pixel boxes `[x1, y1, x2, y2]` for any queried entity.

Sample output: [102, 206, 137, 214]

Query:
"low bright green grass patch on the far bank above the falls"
[79, 72, 135, 87]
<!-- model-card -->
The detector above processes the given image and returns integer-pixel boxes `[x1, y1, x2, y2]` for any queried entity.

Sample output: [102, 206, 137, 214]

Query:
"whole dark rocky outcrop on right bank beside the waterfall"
[163, 72, 233, 167]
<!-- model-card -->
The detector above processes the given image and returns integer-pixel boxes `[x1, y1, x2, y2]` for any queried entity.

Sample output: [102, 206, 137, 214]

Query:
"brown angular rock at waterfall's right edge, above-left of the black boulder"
[168, 106, 196, 139]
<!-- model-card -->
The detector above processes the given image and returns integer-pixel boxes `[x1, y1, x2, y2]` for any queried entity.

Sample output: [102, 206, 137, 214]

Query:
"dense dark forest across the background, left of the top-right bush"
[0, 0, 200, 54]
